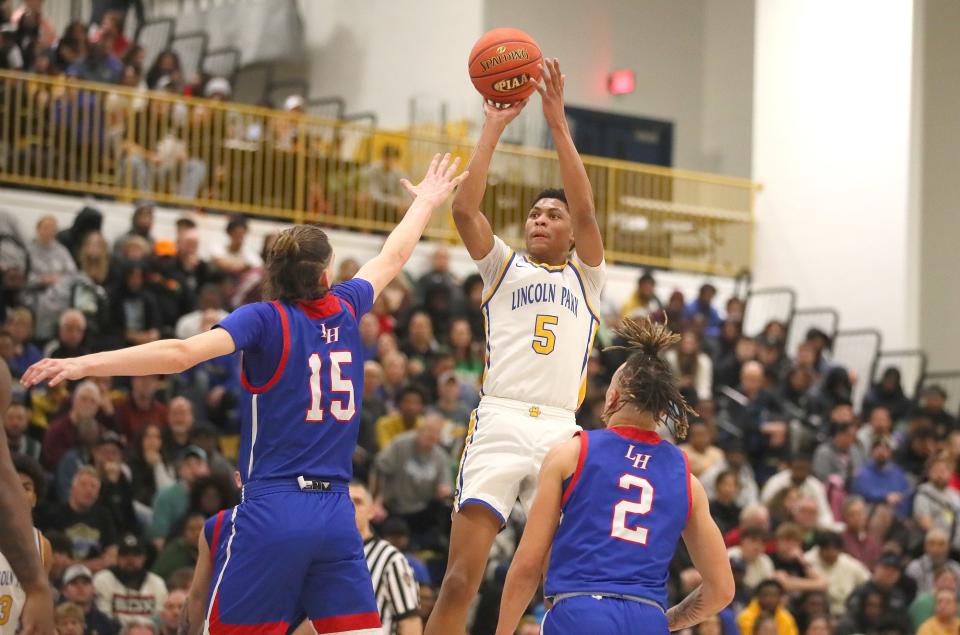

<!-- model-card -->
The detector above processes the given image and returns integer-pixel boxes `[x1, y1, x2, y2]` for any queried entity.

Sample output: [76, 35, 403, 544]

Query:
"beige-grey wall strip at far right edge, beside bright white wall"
[920, 0, 960, 370]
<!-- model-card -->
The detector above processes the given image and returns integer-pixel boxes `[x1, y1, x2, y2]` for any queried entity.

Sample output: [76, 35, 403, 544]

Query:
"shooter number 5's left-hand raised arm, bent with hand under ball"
[453, 99, 527, 260]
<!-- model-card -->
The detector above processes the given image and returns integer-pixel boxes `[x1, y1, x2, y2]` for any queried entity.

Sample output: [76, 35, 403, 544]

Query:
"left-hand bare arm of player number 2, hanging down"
[496, 439, 580, 635]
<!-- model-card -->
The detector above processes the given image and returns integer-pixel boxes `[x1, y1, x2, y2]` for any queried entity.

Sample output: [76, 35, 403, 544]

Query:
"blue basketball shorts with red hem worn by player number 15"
[207, 480, 382, 635]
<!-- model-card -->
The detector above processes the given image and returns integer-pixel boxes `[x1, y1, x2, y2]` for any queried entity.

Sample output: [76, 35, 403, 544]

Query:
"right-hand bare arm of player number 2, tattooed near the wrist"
[667, 476, 735, 631]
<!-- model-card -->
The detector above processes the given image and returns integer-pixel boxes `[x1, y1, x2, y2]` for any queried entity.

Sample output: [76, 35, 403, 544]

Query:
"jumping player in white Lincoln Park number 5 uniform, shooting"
[425, 60, 605, 635]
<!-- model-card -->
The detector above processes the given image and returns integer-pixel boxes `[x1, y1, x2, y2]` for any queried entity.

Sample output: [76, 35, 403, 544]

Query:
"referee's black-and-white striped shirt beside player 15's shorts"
[363, 537, 420, 635]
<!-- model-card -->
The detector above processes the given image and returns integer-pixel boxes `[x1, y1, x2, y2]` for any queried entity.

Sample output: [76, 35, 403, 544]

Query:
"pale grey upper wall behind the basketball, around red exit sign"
[296, 0, 754, 176]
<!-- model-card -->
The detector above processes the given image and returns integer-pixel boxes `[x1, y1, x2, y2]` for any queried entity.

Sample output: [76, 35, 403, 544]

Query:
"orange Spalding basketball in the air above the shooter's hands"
[469, 28, 541, 104]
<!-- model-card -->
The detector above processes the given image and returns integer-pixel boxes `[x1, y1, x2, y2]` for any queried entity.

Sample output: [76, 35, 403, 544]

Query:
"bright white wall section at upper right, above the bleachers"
[753, 0, 919, 348]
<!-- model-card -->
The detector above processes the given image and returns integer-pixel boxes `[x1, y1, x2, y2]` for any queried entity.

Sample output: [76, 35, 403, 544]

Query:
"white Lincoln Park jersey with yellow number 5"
[477, 236, 606, 410]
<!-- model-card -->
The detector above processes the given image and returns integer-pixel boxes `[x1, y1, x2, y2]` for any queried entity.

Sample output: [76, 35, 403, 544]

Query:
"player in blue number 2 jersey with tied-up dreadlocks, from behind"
[497, 320, 734, 635]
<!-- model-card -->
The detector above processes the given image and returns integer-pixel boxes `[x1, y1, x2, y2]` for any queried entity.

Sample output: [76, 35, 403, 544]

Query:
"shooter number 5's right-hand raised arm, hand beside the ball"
[537, 58, 603, 267]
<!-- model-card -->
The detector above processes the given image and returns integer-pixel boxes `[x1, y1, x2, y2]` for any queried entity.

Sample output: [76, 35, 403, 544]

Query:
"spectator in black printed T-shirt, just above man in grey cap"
[40, 465, 117, 572]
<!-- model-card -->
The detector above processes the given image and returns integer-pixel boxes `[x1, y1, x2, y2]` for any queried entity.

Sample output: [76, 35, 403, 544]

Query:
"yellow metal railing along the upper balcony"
[0, 71, 757, 275]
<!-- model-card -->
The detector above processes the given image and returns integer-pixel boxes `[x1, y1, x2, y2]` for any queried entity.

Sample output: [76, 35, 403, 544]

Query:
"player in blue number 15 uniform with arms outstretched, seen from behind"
[21, 154, 467, 635]
